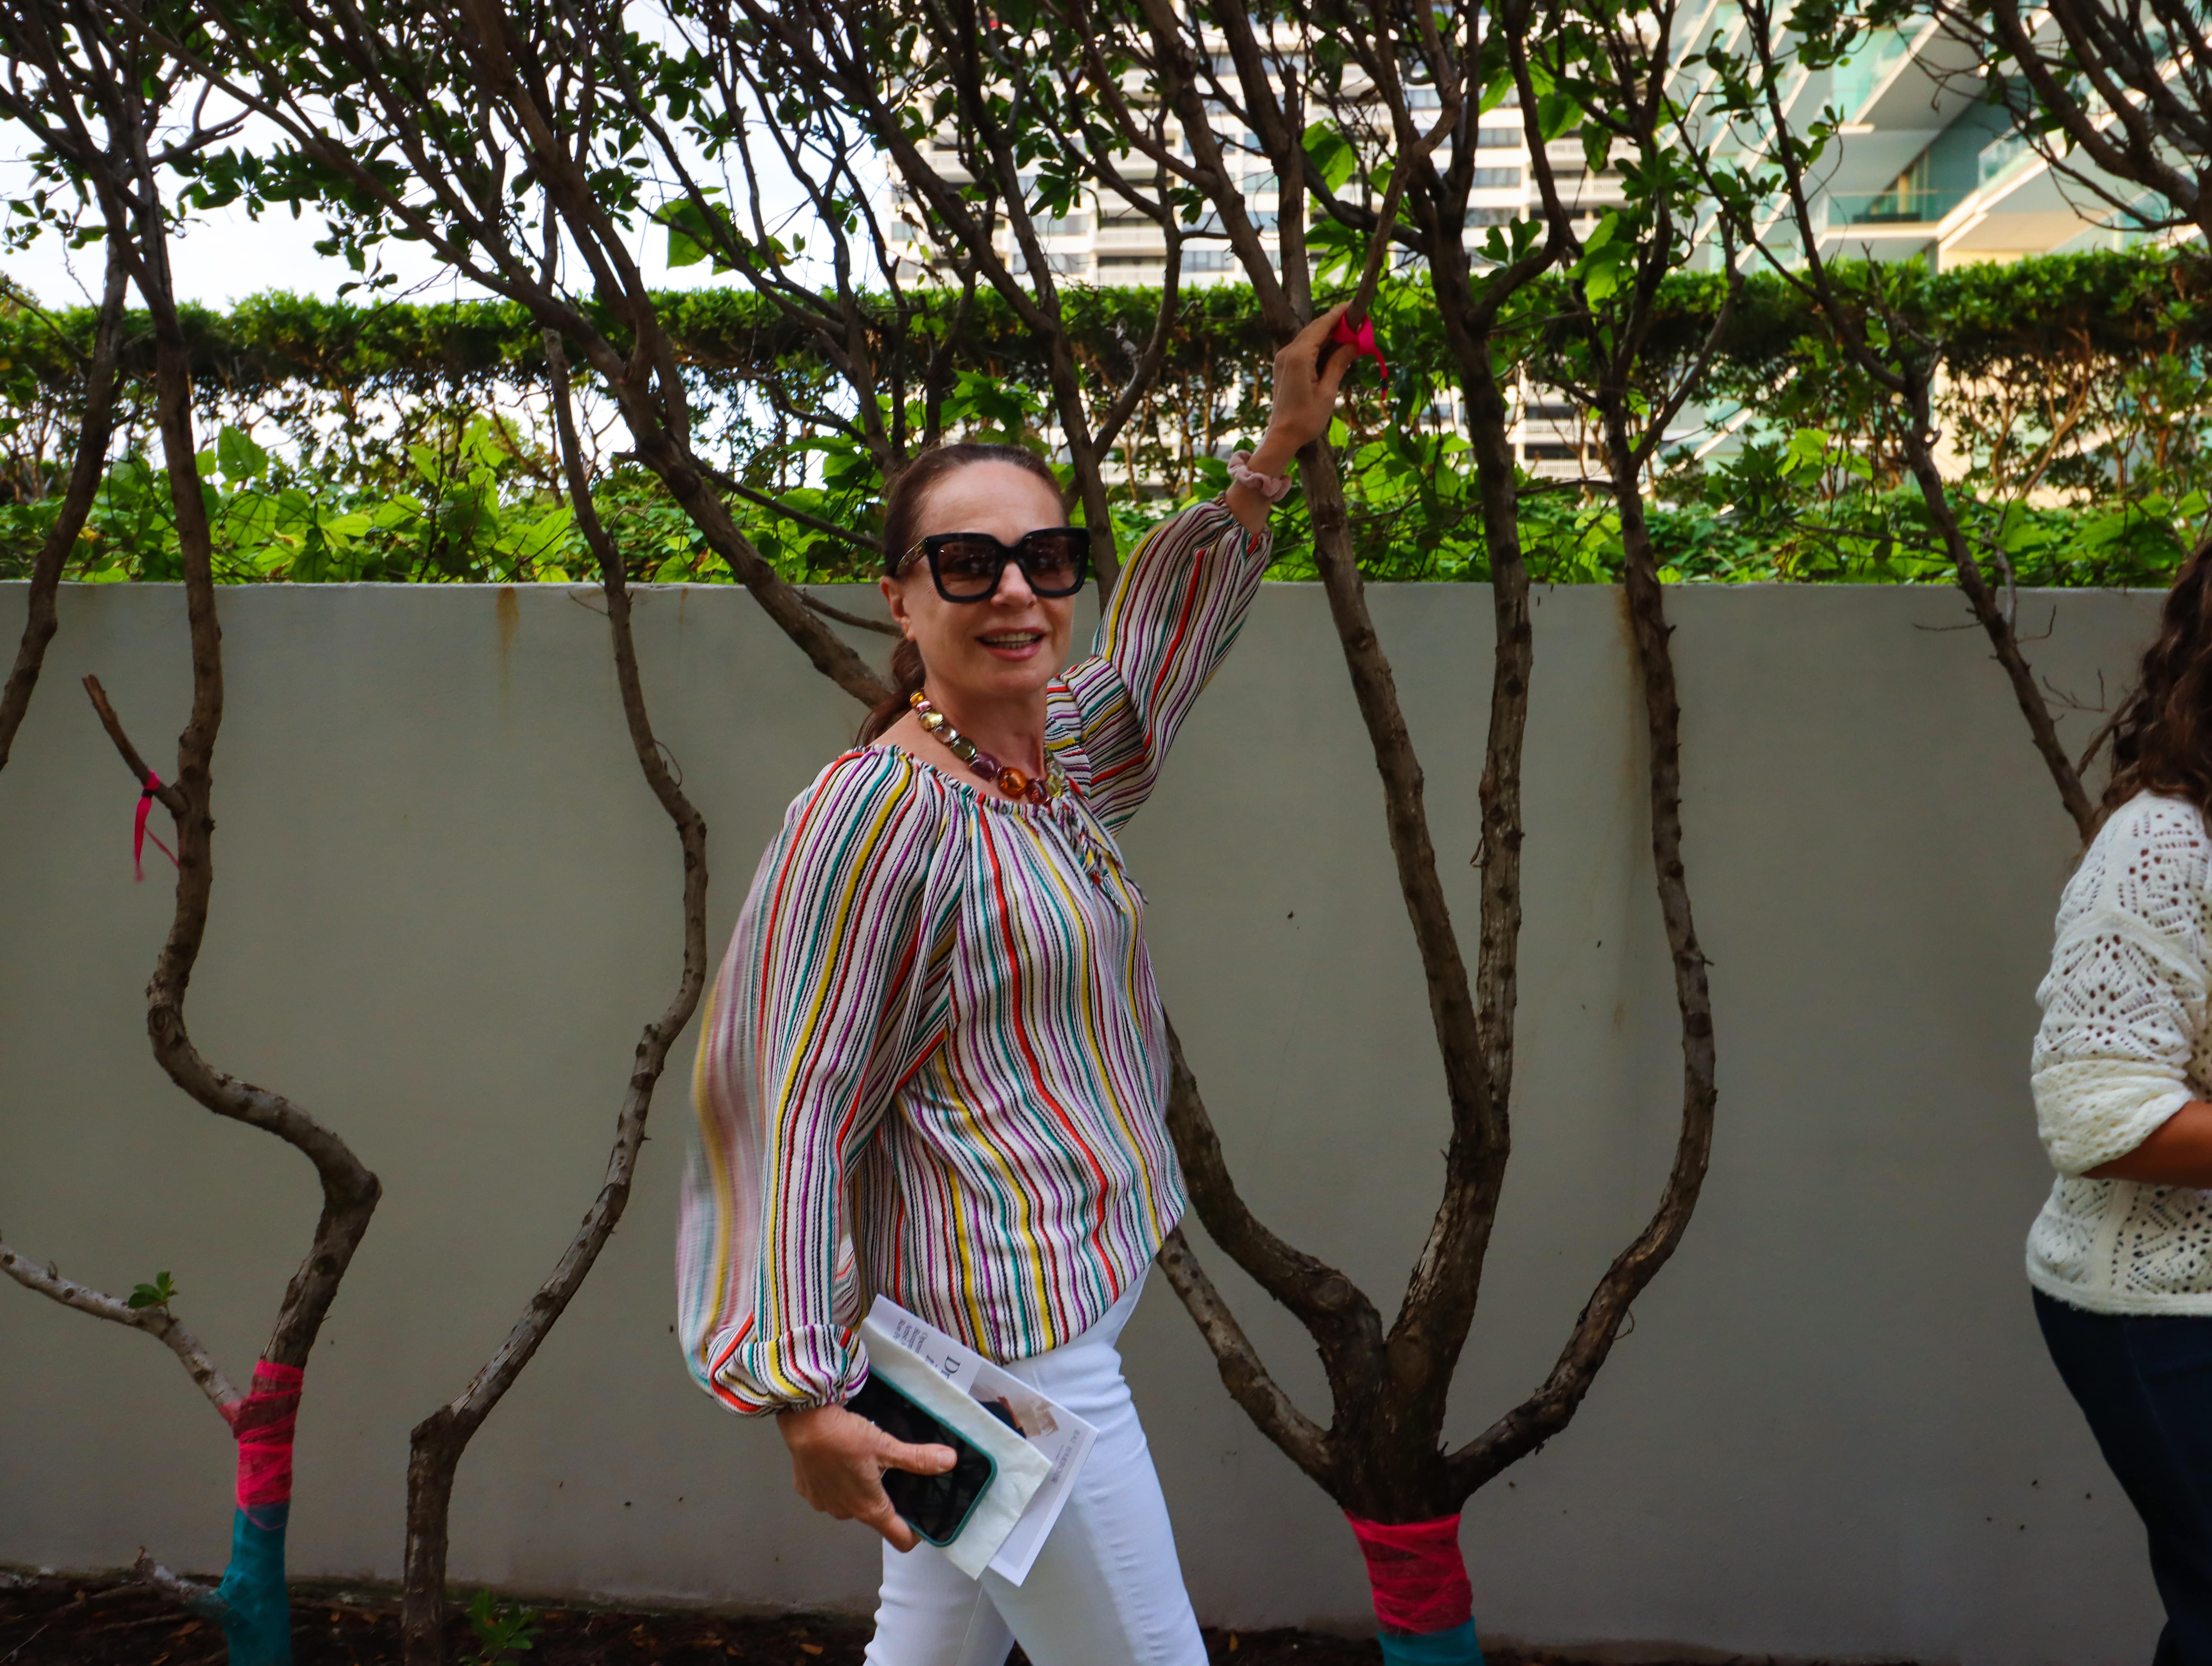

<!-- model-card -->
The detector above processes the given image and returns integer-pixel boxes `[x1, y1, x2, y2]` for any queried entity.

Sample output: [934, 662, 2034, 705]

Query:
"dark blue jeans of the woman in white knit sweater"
[2035, 1290, 2212, 1666]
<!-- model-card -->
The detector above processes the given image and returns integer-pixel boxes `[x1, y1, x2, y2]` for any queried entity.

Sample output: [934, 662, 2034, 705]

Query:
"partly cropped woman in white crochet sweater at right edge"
[2029, 562, 2212, 1666]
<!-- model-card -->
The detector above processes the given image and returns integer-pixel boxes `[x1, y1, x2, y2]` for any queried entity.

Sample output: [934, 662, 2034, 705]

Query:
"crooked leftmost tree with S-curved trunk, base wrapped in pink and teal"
[0, 16, 383, 1666]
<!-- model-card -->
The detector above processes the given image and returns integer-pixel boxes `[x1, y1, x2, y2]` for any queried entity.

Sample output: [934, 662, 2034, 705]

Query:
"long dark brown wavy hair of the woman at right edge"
[2097, 538, 2212, 823]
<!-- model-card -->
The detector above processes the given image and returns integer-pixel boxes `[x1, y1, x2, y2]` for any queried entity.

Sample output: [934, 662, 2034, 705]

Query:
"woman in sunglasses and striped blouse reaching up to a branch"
[679, 312, 1349, 1666]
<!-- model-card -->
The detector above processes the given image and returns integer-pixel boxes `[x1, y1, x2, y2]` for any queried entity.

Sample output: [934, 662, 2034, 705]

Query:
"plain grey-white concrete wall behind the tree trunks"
[0, 571, 2157, 1666]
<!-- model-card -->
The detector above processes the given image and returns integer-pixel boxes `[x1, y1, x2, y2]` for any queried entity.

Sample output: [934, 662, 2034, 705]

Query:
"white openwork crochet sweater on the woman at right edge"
[2029, 792, 2212, 1314]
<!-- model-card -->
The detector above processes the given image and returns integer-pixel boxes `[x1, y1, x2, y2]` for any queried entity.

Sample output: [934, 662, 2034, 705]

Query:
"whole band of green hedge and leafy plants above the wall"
[0, 250, 2212, 584]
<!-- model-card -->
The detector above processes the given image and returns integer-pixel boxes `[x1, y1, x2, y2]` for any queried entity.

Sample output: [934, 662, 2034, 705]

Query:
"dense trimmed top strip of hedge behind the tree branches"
[0, 248, 2212, 392]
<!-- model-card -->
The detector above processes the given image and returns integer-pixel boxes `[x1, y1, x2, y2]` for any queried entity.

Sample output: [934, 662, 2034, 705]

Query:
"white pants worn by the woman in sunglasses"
[867, 1279, 1205, 1666]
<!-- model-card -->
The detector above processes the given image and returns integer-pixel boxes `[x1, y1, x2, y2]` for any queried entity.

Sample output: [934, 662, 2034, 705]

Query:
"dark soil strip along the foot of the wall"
[0, 1573, 1911, 1666]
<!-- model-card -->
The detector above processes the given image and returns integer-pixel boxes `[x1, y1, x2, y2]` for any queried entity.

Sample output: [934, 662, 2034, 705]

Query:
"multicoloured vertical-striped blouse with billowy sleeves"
[677, 502, 1268, 1411]
